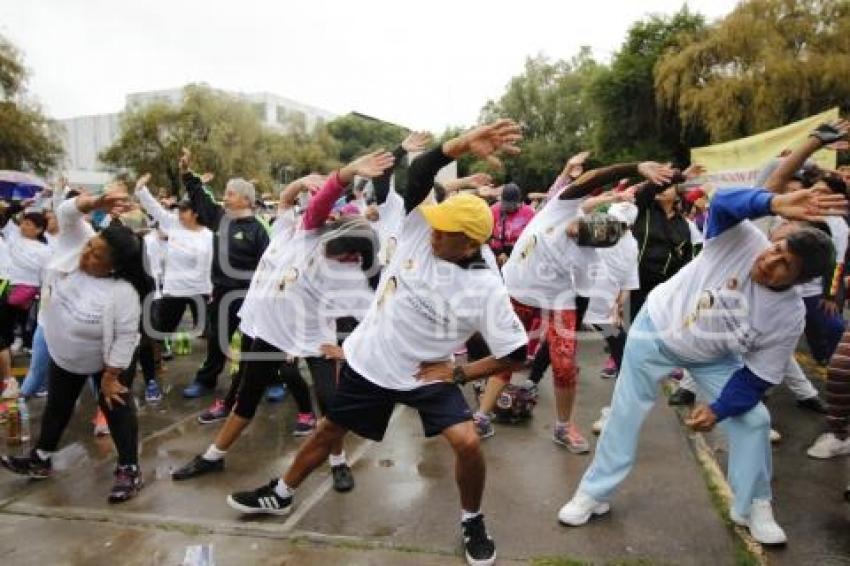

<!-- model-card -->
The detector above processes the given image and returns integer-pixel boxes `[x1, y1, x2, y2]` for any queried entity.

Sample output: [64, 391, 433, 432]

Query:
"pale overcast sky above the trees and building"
[0, 0, 737, 132]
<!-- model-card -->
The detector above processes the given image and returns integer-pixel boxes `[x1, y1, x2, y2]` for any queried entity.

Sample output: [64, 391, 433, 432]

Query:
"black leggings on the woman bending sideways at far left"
[36, 360, 139, 466]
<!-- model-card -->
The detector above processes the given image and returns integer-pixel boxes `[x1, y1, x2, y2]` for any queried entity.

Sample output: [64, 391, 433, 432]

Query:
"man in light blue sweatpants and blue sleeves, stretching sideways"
[558, 121, 850, 544]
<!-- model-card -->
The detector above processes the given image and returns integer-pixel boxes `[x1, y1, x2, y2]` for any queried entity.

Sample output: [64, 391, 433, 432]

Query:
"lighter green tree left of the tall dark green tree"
[470, 47, 600, 192]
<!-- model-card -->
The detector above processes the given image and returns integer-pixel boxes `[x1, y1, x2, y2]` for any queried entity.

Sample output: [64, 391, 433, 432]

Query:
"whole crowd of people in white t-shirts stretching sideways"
[0, 120, 850, 565]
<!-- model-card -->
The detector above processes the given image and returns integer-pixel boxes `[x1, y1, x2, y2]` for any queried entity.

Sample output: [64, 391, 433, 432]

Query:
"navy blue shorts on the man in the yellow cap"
[325, 364, 472, 441]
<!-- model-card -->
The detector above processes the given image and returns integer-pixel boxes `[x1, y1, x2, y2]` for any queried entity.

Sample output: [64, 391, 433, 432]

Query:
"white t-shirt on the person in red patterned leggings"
[502, 197, 599, 310]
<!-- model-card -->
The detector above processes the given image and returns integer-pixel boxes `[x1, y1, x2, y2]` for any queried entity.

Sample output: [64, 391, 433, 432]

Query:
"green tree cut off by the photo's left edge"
[0, 36, 62, 174]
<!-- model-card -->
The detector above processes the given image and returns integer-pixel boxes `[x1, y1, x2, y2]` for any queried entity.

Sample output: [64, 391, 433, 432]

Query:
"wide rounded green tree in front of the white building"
[100, 85, 338, 195]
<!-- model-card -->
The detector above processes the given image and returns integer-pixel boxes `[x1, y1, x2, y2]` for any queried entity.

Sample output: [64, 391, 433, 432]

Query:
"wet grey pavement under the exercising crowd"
[0, 341, 850, 565]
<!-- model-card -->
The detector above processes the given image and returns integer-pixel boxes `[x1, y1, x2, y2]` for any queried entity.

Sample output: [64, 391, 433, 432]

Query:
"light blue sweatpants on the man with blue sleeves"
[578, 308, 773, 517]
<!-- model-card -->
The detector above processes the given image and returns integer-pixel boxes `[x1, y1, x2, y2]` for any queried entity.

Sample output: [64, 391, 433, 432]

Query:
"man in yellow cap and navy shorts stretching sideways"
[228, 120, 527, 565]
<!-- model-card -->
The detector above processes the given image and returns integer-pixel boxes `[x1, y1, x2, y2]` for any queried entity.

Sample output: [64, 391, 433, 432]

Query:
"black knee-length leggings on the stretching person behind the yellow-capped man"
[230, 336, 336, 419]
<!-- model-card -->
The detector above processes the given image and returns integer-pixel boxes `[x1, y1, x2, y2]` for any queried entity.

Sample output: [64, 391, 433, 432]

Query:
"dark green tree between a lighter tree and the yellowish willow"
[588, 6, 707, 163]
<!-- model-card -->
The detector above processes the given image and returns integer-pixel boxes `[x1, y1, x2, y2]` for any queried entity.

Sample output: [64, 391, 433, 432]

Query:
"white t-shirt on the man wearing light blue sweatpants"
[646, 220, 805, 383]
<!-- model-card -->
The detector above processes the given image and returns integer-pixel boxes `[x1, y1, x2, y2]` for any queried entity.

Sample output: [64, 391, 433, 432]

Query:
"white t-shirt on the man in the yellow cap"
[343, 209, 527, 391]
